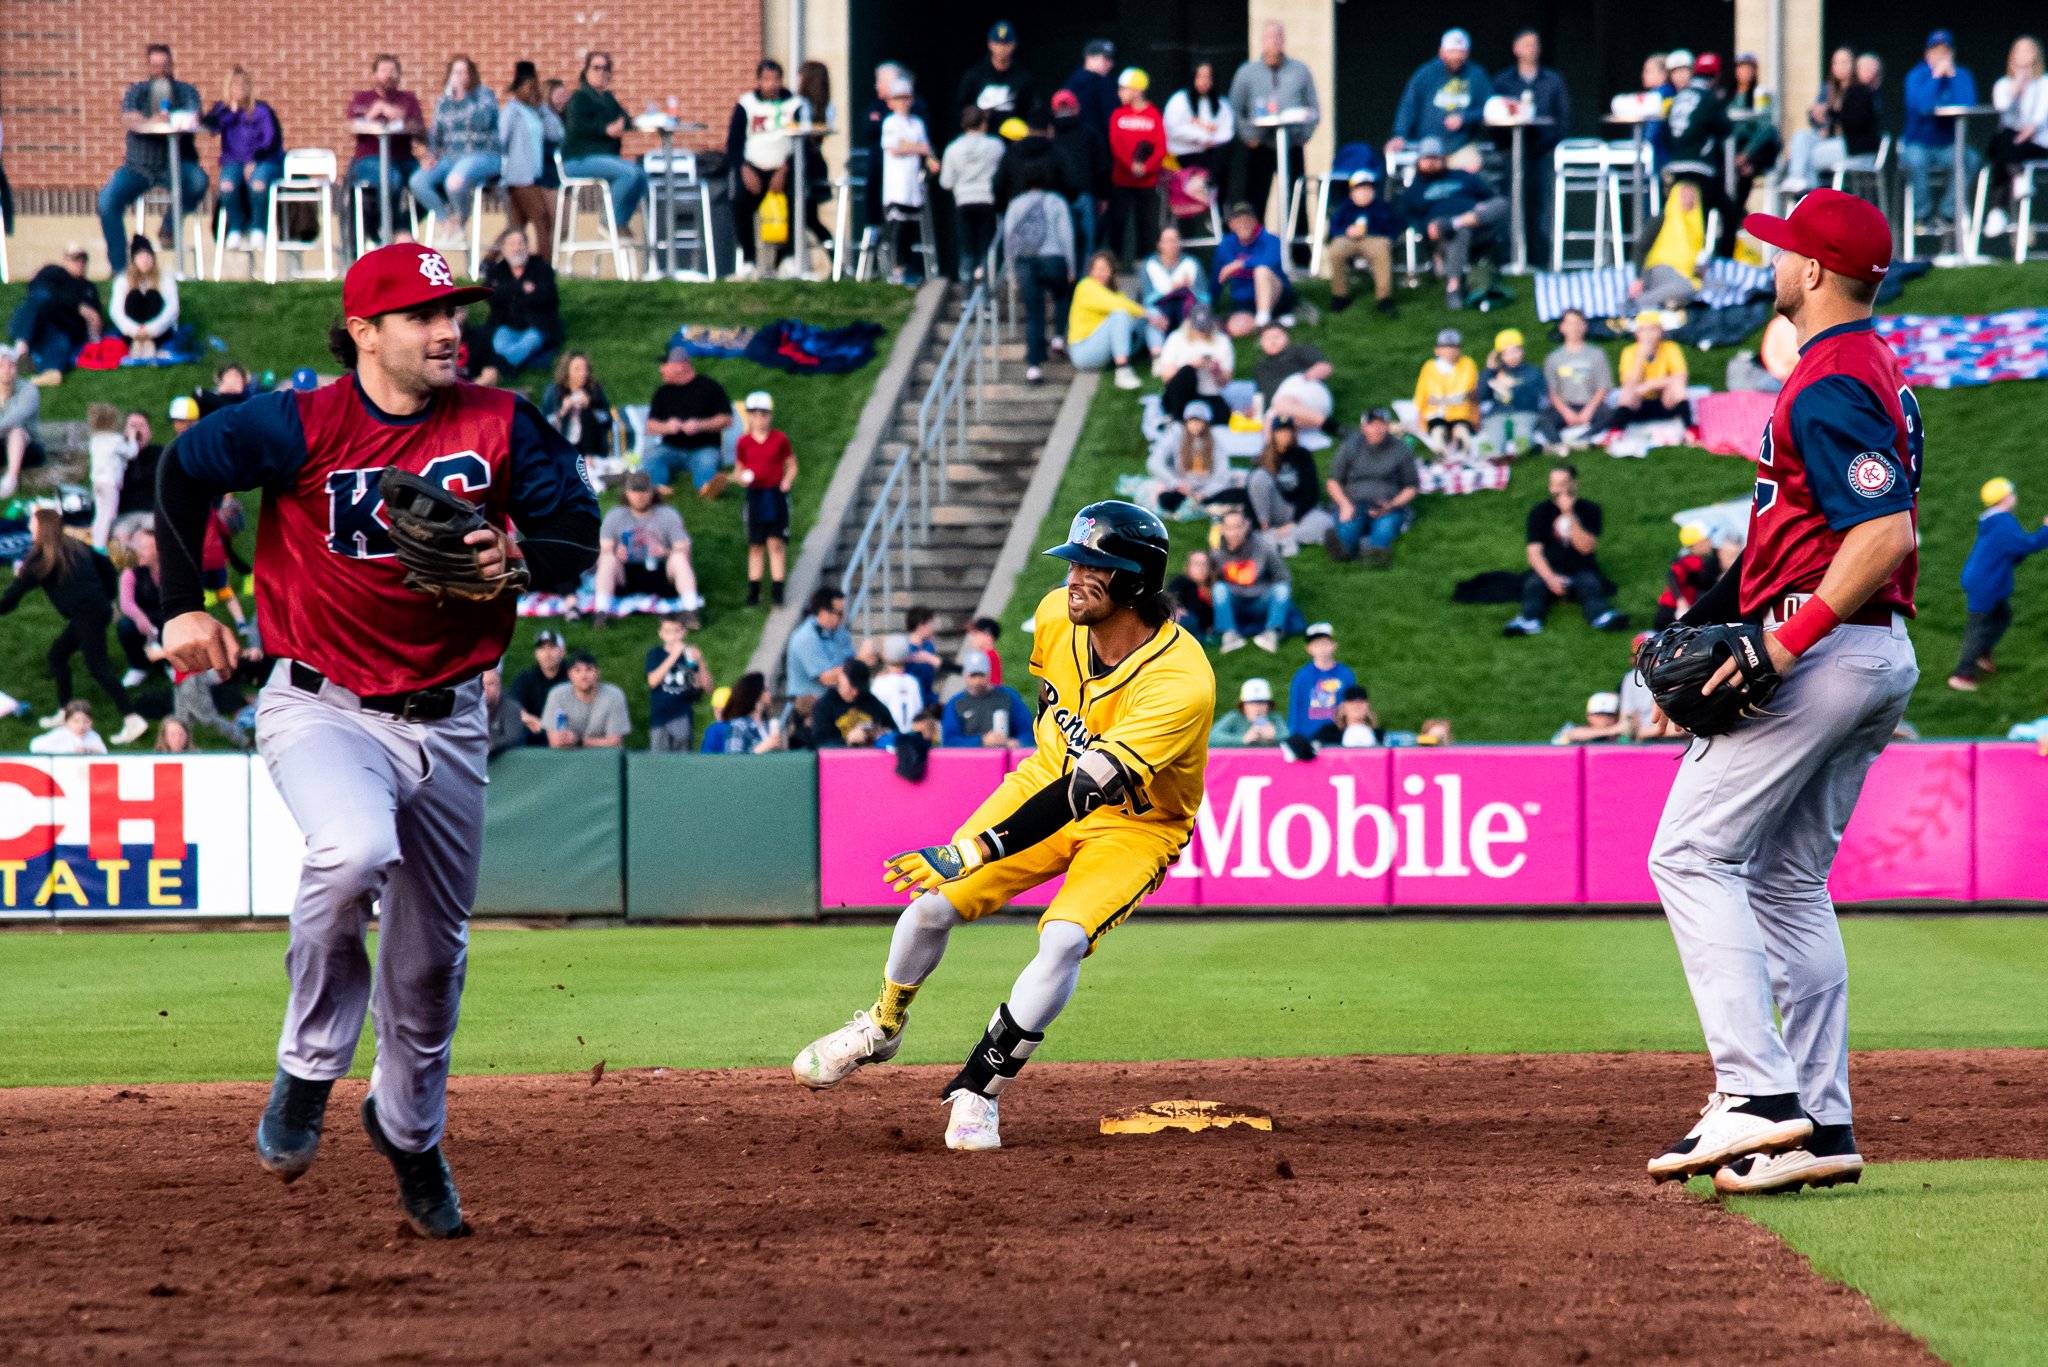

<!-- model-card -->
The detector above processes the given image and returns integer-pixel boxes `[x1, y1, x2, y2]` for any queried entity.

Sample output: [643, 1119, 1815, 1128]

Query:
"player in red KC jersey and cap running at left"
[156, 244, 598, 1238]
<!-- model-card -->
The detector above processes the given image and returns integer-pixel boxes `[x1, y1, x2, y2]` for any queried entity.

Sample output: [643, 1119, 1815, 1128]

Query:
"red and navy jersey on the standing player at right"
[1741, 320, 1925, 617]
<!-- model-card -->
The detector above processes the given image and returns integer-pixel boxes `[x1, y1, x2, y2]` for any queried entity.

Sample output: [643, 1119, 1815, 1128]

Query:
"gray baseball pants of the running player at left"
[256, 660, 489, 1152]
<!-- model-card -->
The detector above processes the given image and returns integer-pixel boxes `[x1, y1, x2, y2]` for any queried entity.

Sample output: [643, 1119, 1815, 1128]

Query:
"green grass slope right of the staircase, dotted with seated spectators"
[1004, 264, 2048, 740]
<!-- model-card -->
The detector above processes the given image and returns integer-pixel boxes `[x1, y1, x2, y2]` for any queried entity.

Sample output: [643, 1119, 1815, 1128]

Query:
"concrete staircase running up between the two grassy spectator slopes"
[823, 287, 1073, 654]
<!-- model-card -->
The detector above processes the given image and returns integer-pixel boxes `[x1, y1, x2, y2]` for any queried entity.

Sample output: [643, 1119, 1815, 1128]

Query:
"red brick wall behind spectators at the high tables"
[0, 0, 762, 189]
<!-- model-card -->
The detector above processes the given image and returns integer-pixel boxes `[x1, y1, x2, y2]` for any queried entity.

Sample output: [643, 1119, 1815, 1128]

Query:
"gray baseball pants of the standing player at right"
[1651, 621, 1919, 1125]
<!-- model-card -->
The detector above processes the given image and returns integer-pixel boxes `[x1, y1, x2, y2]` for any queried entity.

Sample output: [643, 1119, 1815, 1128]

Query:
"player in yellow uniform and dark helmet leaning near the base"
[795, 502, 1217, 1150]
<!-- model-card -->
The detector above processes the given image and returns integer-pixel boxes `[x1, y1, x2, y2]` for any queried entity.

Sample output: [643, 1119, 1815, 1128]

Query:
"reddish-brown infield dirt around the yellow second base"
[0, 1049, 2048, 1367]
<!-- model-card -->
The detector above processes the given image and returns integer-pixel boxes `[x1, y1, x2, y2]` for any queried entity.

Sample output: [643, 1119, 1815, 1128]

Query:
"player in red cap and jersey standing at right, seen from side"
[1649, 191, 1923, 1193]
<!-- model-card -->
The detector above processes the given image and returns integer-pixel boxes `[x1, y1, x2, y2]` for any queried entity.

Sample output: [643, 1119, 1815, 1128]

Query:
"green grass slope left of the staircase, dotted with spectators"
[0, 281, 911, 752]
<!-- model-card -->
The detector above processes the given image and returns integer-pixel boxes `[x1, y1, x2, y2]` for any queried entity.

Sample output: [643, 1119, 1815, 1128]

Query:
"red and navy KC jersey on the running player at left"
[176, 377, 598, 697]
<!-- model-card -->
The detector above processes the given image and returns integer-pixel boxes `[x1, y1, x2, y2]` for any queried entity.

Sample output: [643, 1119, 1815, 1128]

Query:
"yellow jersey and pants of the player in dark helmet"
[944, 588, 1217, 947]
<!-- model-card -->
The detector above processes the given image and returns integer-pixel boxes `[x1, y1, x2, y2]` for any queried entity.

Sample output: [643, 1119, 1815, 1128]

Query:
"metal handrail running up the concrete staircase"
[840, 238, 1016, 635]
